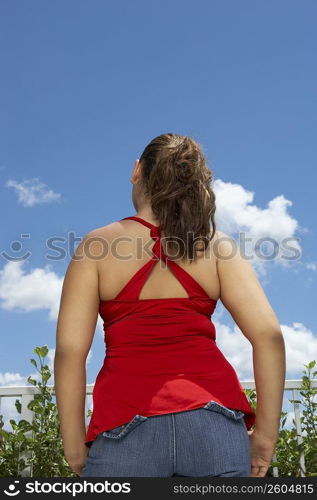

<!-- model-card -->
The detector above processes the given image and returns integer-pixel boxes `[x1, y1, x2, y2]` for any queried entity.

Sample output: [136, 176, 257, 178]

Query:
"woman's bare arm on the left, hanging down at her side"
[54, 233, 99, 472]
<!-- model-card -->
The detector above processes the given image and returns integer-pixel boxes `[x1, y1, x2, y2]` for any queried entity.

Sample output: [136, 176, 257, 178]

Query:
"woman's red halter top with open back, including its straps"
[85, 216, 255, 447]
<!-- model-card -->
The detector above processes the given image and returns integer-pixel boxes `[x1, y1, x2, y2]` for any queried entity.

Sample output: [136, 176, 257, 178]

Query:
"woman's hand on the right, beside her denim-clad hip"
[248, 429, 276, 477]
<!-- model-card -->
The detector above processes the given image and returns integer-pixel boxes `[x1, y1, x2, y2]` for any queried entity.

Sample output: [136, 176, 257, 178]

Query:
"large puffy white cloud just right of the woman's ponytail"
[213, 179, 301, 274]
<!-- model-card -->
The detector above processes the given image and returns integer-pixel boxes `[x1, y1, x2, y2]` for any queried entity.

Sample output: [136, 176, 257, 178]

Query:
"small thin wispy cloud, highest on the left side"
[6, 177, 61, 207]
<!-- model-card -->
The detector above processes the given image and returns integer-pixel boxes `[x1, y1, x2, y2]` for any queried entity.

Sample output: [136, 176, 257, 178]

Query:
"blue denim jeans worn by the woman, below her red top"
[81, 401, 251, 477]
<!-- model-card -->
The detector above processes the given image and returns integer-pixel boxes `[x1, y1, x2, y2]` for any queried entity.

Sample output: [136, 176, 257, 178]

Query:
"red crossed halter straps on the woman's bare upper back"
[114, 216, 210, 300]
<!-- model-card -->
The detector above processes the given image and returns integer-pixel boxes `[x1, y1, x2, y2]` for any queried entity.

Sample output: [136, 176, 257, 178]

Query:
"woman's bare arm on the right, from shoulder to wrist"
[215, 232, 285, 476]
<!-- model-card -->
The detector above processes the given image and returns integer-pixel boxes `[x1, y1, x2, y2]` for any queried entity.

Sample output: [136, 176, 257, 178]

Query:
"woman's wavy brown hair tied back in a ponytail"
[139, 133, 216, 261]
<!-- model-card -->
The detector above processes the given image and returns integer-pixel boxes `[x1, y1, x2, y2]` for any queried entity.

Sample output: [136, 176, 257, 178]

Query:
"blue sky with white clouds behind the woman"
[0, 0, 317, 428]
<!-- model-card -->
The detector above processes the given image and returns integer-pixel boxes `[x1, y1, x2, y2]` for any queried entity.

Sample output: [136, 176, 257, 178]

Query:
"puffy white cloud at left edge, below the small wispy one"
[0, 261, 63, 320]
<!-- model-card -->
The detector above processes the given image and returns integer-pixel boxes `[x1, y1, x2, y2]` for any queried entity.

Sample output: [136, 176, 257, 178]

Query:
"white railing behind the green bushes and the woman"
[0, 380, 317, 477]
